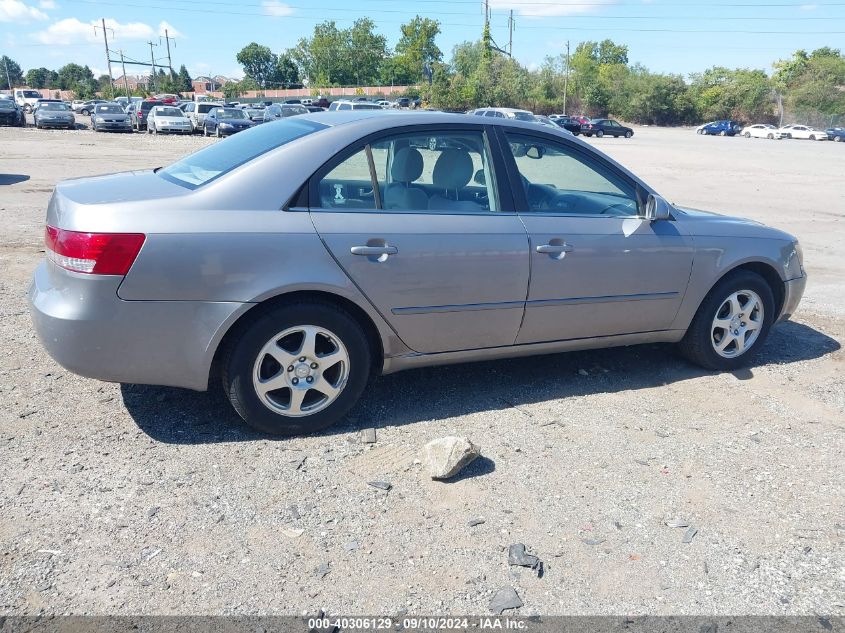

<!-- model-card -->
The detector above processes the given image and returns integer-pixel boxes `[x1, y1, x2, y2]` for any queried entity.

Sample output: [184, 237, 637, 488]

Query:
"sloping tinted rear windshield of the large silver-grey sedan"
[158, 119, 326, 189]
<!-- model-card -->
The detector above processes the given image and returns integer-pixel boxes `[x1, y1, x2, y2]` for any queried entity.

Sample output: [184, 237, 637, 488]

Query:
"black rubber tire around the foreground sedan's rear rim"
[223, 302, 372, 435]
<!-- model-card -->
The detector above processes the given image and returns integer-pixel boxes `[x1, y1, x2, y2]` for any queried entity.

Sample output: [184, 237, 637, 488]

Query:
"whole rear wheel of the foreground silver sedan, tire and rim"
[223, 303, 371, 435]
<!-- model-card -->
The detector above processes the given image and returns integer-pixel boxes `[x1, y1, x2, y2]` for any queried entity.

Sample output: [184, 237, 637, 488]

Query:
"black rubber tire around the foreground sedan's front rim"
[678, 270, 775, 371]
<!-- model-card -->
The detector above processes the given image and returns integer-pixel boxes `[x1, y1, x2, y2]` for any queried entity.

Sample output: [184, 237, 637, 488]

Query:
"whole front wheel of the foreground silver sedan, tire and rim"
[680, 270, 775, 370]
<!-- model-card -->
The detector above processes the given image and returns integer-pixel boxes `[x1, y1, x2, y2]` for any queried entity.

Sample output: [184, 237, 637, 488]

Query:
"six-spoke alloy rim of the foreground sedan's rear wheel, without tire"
[252, 325, 349, 417]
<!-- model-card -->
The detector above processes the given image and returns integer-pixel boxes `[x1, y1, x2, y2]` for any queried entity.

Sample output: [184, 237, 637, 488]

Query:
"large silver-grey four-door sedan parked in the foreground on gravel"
[29, 111, 806, 434]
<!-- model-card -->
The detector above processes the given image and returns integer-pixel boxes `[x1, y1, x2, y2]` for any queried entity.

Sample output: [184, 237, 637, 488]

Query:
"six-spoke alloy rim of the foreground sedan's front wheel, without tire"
[710, 290, 764, 358]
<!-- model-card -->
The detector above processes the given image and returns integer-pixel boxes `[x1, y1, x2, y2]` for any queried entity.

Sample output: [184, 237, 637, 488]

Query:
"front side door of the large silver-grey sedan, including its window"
[494, 133, 692, 344]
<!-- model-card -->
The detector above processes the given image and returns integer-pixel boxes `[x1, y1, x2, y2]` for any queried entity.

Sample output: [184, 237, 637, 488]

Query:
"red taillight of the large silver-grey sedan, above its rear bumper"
[44, 226, 146, 275]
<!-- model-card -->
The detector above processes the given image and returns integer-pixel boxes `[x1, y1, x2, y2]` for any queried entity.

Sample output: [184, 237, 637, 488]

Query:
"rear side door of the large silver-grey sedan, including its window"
[309, 125, 529, 352]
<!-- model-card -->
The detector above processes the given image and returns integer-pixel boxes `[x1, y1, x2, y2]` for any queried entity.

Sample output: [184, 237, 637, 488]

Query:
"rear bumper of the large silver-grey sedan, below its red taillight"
[29, 261, 251, 391]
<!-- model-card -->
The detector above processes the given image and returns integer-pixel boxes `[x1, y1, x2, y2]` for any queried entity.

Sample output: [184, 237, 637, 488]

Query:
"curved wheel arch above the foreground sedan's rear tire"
[208, 290, 384, 385]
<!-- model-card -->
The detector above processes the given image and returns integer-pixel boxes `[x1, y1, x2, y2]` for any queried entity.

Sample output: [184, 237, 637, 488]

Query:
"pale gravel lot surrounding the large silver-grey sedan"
[0, 121, 845, 615]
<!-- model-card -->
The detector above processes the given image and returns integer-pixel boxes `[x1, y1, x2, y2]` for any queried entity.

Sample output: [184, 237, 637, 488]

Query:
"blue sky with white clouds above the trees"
[0, 0, 845, 77]
